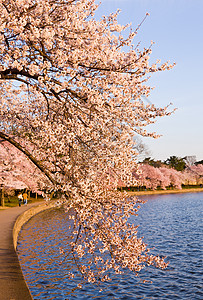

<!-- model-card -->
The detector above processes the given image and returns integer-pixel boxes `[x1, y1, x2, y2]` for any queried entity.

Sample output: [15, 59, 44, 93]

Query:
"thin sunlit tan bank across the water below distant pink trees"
[127, 188, 203, 196]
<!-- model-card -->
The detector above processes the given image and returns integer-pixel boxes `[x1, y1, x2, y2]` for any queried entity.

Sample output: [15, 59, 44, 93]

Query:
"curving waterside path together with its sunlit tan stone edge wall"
[0, 201, 55, 300]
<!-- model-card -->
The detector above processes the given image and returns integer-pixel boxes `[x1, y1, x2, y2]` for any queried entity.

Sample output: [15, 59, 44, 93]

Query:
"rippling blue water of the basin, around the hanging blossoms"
[18, 193, 203, 300]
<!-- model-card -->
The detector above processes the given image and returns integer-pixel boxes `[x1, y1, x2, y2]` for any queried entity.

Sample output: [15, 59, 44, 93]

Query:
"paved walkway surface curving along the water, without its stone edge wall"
[0, 202, 43, 300]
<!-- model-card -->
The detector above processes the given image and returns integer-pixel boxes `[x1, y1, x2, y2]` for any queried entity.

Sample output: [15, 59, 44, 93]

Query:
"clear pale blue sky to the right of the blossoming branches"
[96, 0, 203, 160]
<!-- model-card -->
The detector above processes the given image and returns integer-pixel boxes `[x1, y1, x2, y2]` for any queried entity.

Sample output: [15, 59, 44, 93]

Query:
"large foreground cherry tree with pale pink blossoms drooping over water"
[0, 0, 172, 282]
